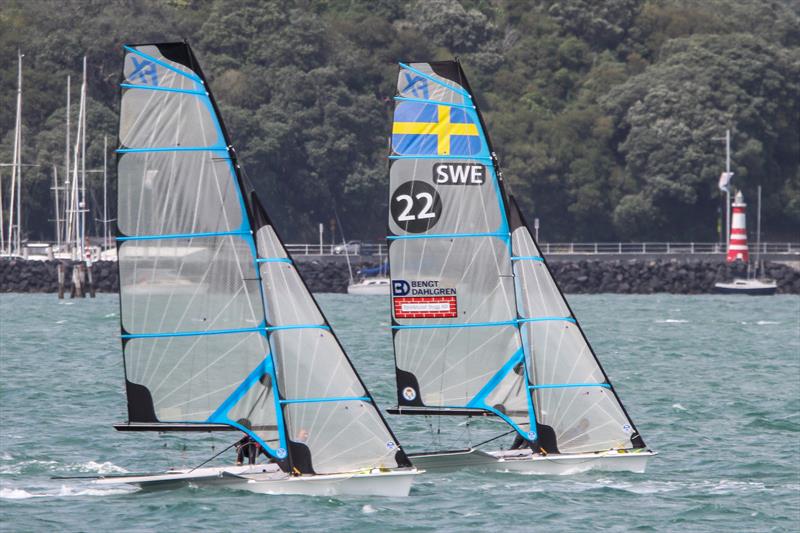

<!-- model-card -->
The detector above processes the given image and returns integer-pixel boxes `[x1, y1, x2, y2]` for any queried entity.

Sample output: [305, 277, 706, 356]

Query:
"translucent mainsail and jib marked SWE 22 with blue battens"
[388, 61, 644, 453]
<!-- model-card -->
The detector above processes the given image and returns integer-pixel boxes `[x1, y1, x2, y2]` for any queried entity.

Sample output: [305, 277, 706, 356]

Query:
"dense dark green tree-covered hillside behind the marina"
[0, 0, 800, 241]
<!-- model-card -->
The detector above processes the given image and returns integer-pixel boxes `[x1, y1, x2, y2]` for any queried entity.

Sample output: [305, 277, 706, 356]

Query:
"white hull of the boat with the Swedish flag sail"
[411, 449, 656, 475]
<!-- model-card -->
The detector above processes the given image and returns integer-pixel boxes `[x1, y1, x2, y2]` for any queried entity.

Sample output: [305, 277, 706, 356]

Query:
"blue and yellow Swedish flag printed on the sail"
[392, 102, 481, 156]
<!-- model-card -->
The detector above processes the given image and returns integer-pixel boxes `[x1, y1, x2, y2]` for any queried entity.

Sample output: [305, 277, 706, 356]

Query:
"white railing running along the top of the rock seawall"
[286, 242, 800, 257]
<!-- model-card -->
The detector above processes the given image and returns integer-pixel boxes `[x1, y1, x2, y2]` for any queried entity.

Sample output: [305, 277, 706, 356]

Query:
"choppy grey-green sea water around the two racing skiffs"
[0, 294, 800, 532]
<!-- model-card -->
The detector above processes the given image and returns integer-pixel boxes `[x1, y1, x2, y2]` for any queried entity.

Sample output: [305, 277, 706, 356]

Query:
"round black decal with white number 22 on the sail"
[389, 180, 442, 233]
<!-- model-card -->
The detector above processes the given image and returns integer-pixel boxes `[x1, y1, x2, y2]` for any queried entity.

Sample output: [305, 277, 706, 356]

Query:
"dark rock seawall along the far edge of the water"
[0, 259, 800, 294]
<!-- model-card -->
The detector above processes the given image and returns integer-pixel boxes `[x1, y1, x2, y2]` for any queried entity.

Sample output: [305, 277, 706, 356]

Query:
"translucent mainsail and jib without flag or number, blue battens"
[117, 43, 409, 474]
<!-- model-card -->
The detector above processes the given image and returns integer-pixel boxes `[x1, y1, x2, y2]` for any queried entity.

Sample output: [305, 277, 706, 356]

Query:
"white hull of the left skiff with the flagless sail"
[93, 464, 423, 497]
